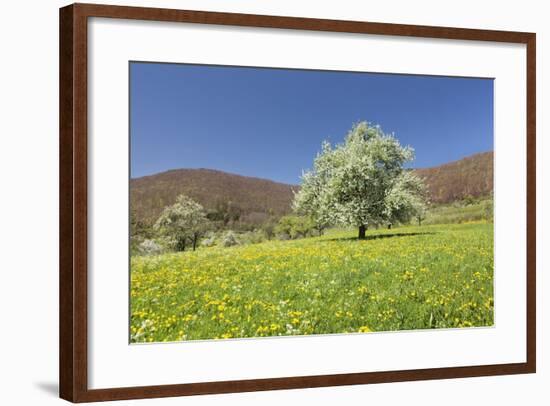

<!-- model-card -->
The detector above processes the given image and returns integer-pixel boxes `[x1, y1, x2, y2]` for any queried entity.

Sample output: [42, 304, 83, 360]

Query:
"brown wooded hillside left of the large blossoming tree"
[130, 169, 298, 223]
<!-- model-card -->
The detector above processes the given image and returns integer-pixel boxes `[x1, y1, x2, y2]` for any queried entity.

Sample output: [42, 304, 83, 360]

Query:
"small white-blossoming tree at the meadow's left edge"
[155, 195, 208, 251]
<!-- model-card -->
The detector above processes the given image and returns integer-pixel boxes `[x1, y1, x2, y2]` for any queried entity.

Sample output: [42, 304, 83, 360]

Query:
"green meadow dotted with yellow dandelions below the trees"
[130, 223, 493, 343]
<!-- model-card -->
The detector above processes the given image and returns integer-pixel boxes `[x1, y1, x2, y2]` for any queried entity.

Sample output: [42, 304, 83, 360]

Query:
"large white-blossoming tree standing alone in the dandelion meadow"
[294, 122, 430, 238]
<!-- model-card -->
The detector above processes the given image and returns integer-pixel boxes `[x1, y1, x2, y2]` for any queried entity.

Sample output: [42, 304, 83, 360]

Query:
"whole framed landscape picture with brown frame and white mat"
[60, 4, 536, 402]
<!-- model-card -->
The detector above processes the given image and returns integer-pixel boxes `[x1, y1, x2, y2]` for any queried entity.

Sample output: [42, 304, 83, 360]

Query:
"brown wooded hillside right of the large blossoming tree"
[415, 152, 493, 203]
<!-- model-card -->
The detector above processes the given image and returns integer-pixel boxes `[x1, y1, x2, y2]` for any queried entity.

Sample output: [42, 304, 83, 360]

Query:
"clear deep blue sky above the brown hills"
[130, 62, 493, 183]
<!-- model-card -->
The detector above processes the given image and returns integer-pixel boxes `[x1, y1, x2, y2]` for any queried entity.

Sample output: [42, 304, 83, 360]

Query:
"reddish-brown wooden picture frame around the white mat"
[59, 4, 536, 402]
